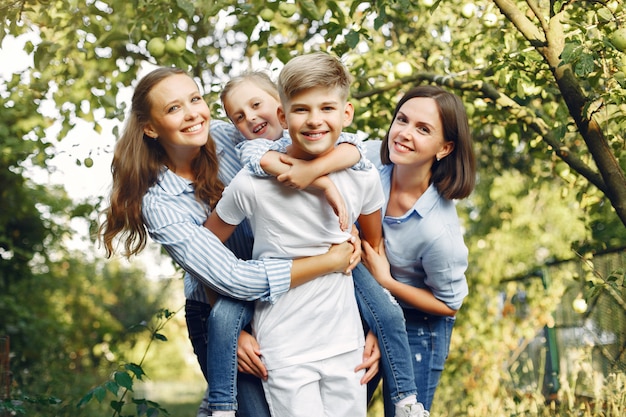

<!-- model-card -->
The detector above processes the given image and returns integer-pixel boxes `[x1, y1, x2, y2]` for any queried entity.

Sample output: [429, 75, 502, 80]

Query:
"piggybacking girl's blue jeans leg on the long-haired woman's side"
[207, 297, 254, 410]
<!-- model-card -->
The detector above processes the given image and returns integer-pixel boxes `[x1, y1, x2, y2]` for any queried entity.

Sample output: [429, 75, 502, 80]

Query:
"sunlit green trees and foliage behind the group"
[0, 0, 626, 416]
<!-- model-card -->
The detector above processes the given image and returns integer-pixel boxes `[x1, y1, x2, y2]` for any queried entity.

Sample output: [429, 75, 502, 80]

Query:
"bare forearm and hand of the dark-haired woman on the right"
[363, 242, 457, 317]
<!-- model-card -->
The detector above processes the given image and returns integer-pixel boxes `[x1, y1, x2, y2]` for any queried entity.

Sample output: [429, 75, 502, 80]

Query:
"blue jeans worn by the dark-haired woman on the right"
[376, 308, 456, 417]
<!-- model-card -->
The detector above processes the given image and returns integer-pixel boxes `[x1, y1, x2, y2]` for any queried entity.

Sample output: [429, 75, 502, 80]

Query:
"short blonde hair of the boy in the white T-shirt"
[277, 52, 352, 105]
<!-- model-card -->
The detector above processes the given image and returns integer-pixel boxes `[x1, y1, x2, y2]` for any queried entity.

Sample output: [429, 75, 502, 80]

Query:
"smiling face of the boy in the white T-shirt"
[278, 88, 354, 159]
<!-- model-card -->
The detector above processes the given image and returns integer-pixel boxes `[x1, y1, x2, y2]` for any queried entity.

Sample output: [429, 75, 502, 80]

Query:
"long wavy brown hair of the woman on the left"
[99, 67, 224, 257]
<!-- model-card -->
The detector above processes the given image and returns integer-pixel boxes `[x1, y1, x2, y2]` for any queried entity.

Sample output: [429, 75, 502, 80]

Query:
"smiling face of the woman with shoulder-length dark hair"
[387, 97, 454, 169]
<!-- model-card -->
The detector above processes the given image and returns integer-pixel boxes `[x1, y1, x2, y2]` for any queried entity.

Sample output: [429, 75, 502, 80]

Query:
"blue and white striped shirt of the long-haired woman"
[142, 120, 292, 302]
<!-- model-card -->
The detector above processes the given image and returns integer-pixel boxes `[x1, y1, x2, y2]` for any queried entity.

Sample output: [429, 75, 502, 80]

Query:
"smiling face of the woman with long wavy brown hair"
[144, 74, 211, 154]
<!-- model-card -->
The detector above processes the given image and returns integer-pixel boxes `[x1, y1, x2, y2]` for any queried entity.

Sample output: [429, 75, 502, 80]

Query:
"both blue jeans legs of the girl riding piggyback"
[208, 264, 417, 410]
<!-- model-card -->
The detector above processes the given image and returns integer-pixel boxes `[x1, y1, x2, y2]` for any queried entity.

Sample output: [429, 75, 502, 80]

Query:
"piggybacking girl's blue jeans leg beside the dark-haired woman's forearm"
[352, 264, 417, 405]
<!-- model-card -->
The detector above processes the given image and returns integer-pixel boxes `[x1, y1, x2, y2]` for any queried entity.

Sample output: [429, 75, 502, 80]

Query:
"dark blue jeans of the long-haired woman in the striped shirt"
[185, 300, 270, 417]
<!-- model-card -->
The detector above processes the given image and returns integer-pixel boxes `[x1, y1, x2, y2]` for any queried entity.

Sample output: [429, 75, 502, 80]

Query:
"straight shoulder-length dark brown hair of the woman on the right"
[380, 85, 476, 200]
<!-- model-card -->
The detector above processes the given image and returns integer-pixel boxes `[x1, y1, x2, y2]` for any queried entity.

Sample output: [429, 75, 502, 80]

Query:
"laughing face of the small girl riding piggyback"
[224, 81, 283, 140]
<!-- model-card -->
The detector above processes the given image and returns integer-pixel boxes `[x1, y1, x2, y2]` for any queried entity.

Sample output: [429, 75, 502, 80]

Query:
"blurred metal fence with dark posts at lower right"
[504, 248, 626, 400]
